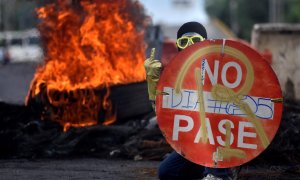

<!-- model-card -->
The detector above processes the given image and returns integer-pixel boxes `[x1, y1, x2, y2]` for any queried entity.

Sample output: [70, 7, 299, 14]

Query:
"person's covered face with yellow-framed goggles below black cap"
[176, 32, 205, 50]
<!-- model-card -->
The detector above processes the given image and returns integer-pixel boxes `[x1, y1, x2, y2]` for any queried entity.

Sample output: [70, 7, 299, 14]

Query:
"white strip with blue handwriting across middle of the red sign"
[162, 87, 274, 120]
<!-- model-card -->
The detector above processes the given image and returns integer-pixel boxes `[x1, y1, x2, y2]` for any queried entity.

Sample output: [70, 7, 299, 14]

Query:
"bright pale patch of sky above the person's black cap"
[140, 0, 208, 25]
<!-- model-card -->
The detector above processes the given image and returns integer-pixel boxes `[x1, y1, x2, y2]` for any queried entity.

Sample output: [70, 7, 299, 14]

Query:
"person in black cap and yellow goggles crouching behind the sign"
[144, 22, 231, 180]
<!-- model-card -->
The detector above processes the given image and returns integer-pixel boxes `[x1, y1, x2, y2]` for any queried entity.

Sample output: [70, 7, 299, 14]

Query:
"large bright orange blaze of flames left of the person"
[26, 0, 145, 130]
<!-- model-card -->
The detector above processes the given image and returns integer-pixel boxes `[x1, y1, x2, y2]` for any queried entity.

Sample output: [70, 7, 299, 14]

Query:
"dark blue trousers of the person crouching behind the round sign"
[158, 151, 230, 180]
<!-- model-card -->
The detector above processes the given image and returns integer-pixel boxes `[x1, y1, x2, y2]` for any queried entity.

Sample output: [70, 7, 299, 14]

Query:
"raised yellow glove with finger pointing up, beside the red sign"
[144, 48, 162, 101]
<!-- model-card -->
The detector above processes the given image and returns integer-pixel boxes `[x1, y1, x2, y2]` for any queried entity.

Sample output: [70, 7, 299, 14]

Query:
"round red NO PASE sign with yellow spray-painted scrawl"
[156, 40, 282, 168]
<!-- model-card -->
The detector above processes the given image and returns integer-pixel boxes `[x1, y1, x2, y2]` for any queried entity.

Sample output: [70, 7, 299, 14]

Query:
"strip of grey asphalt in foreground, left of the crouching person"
[0, 158, 159, 180]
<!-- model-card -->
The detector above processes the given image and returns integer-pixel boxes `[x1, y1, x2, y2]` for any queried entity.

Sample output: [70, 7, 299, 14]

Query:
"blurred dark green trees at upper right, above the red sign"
[205, 0, 300, 40]
